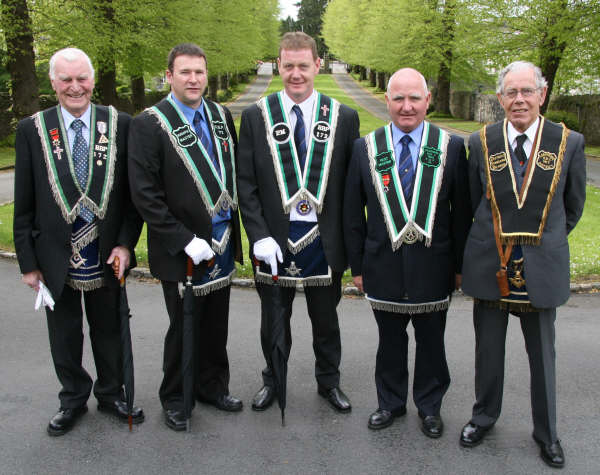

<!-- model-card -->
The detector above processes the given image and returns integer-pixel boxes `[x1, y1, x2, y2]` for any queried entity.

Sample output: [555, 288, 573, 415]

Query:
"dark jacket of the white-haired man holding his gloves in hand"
[14, 108, 142, 299]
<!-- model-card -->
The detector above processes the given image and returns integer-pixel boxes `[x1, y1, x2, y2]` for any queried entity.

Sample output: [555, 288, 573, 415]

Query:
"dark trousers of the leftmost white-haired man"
[46, 285, 122, 409]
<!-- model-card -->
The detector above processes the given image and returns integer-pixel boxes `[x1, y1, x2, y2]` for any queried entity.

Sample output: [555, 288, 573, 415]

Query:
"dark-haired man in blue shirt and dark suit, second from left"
[129, 43, 242, 430]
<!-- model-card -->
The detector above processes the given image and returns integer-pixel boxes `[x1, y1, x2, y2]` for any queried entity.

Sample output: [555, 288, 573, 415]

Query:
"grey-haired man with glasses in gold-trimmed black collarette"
[460, 61, 585, 467]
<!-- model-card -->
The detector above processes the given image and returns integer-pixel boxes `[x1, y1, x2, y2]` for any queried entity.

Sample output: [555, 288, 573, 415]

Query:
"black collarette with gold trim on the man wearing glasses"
[480, 116, 569, 245]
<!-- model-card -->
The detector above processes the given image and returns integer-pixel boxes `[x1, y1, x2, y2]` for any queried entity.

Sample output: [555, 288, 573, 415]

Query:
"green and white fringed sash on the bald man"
[365, 121, 450, 251]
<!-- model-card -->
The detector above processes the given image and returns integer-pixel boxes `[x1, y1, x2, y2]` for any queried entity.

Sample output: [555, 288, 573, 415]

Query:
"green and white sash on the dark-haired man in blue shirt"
[146, 97, 237, 217]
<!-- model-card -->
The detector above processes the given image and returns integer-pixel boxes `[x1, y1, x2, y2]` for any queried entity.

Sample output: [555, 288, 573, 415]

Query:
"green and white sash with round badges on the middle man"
[258, 91, 340, 213]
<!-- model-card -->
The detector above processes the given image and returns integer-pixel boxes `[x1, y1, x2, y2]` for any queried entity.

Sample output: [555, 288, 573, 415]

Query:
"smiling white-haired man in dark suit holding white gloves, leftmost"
[14, 48, 144, 435]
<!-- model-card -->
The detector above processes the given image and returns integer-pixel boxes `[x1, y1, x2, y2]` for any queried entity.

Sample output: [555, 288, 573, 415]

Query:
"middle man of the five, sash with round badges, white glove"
[238, 32, 359, 412]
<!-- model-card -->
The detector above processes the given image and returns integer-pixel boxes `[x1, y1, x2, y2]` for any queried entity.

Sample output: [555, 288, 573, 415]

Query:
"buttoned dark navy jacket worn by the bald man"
[344, 131, 471, 303]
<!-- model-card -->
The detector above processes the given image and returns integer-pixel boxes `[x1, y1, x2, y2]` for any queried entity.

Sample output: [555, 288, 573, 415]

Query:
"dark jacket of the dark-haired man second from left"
[129, 97, 242, 282]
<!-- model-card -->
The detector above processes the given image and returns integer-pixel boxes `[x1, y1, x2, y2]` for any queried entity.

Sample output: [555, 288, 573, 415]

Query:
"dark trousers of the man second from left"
[158, 281, 231, 410]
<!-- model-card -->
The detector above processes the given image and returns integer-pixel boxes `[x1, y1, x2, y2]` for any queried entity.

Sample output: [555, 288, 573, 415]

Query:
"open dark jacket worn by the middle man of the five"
[238, 94, 359, 272]
